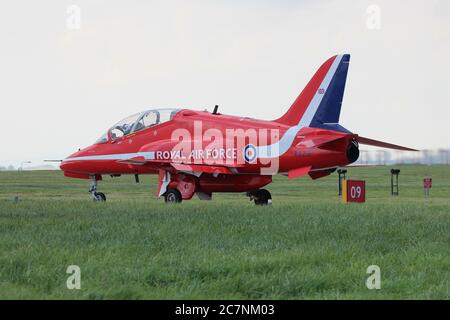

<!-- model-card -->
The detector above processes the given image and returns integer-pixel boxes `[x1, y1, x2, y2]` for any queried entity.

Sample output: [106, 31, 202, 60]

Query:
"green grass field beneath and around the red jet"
[0, 166, 450, 299]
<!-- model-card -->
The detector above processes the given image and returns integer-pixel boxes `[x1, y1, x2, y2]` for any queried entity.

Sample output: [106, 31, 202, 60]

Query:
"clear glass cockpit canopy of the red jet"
[95, 109, 180, 143]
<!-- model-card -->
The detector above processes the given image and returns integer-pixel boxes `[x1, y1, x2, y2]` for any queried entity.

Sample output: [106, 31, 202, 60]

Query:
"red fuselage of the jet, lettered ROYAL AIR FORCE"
[60, 109, 354, 178]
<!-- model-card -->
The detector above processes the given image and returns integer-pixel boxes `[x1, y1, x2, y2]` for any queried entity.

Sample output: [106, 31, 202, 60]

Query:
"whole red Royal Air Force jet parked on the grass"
[61, 54, 417, 205]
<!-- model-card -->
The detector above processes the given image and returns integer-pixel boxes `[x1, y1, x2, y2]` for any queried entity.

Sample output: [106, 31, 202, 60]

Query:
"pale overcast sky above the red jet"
[0, 0, 450, 166]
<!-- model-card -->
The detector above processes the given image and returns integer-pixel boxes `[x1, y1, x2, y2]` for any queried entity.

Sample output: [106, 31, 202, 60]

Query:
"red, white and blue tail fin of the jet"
[275, 54, 350, 132]
